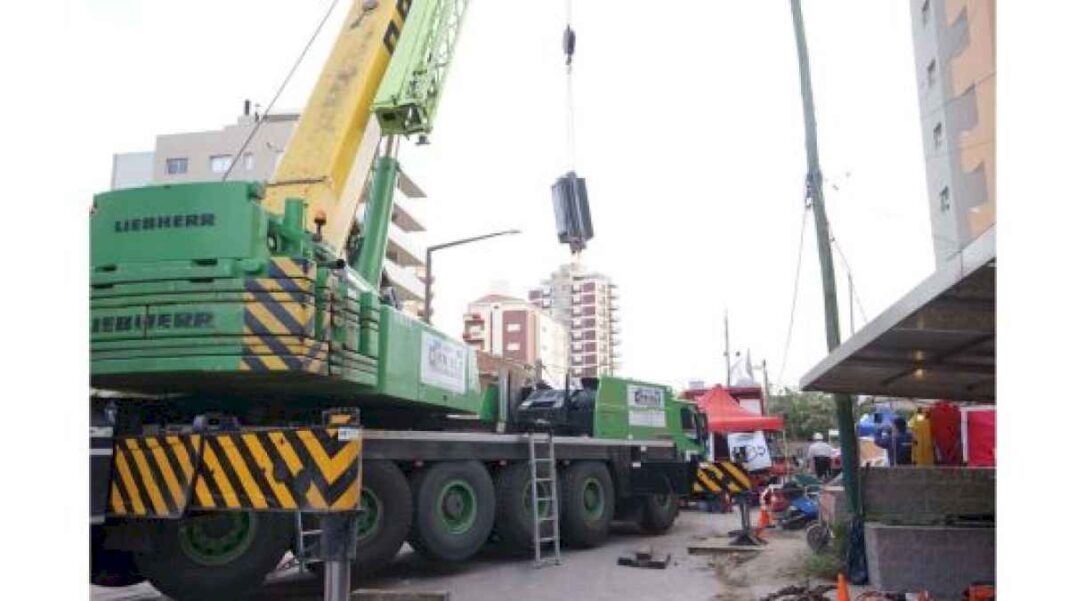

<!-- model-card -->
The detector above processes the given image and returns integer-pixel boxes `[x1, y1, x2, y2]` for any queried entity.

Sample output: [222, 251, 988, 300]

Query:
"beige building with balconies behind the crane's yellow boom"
[111, 108, 426, 316]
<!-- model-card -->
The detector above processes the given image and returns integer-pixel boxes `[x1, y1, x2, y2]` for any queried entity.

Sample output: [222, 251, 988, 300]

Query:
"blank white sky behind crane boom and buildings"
[66, 0, 933, 392]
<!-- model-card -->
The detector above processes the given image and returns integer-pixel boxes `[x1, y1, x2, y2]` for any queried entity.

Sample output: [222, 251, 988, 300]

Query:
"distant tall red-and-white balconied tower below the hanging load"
[529, 263, 623, 377]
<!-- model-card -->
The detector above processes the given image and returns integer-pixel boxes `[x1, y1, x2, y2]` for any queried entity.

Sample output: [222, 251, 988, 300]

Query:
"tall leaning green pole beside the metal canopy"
[790, 0, 861, 516]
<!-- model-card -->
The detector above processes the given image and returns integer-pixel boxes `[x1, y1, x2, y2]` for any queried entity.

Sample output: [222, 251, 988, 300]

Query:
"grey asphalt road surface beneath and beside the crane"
[92, 511, 824, 601]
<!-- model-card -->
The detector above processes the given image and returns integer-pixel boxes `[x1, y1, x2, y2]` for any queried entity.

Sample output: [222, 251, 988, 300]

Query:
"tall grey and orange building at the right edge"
[910, 0, 998, 265]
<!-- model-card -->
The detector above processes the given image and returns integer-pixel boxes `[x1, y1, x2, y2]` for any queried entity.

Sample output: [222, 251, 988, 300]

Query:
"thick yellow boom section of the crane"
[264, 0, 411, 250]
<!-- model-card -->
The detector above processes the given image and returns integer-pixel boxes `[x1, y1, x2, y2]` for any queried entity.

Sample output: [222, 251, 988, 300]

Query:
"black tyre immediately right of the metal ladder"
[560, 461, 615, 548]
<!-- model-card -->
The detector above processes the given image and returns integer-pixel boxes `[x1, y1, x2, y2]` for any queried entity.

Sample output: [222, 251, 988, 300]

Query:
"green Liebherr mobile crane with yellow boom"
[90, 0, 705, 600]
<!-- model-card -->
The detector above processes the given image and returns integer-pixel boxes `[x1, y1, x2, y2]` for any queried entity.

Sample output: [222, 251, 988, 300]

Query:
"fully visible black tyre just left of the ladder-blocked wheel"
[408, 461, 497, 562]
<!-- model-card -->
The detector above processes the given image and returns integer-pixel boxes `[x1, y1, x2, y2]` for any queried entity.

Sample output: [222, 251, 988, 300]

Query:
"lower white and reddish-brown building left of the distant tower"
[464, 295, 568, 386]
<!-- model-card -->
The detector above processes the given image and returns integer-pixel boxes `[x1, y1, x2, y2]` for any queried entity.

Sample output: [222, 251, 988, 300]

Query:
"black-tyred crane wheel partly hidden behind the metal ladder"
[493, 463, 552, 555]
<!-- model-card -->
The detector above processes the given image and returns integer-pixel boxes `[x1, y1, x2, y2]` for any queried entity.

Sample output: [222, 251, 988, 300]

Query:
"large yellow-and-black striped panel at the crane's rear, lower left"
[108, 424, 363, 518]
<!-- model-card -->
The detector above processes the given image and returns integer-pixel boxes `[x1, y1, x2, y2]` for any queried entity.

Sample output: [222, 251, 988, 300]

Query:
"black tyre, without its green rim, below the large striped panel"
[134, 512, 294, 601]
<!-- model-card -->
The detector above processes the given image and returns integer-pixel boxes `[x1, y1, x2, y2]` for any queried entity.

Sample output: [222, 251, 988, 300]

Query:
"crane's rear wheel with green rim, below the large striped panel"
[134, 511, 294, 601]
